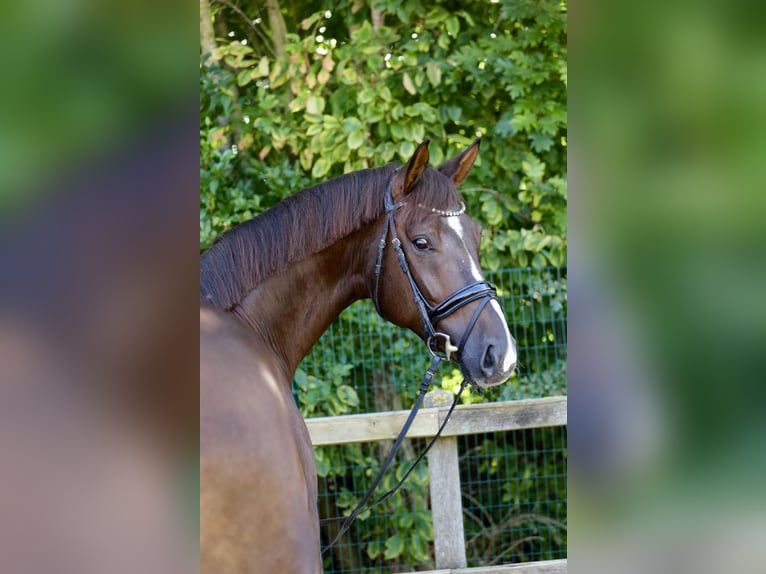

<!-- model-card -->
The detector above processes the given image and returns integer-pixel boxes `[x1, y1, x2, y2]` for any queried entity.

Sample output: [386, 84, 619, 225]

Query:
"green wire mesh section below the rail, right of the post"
[458, 427, 567, 566]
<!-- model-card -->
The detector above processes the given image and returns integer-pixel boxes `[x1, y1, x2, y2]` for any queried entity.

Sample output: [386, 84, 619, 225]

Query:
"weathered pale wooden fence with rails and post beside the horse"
[306, 391, 567, 574]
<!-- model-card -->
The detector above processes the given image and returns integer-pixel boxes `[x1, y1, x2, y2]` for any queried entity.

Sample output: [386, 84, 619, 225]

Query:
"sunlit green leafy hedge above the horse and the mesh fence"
[200, 0, 566, 269]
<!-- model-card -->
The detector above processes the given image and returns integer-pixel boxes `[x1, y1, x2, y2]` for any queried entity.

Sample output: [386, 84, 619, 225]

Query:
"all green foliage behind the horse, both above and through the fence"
[200, 0, 567, 572]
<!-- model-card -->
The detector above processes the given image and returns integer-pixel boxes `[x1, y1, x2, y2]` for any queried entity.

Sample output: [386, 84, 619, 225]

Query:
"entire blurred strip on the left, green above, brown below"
[0, 1, 199, 574]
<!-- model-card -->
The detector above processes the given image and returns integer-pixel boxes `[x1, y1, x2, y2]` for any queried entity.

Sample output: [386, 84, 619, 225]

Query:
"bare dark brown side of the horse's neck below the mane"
[232, 224, 380, 380]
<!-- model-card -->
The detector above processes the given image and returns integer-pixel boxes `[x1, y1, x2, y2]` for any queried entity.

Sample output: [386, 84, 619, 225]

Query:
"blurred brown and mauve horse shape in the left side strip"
[0, 116, 199, 573]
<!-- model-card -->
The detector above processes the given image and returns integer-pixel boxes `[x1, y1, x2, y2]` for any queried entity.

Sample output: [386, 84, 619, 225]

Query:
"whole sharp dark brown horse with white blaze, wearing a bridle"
[200, 139, 516, 574]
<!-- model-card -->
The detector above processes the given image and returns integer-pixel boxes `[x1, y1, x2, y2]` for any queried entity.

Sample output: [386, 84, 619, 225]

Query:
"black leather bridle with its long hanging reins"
[321, 169, 497, 556]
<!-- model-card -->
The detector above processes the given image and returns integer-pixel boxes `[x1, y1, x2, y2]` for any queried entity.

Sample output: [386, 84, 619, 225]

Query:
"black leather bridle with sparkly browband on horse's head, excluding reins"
[373, 170, 504, 361]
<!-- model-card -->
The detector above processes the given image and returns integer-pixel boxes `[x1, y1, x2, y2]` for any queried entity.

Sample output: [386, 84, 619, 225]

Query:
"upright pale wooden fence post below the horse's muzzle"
[424, 390, 466, 568]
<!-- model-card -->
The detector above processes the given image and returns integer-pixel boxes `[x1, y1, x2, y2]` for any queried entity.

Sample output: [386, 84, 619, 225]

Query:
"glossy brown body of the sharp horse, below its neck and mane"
[200, 308, 321, 574]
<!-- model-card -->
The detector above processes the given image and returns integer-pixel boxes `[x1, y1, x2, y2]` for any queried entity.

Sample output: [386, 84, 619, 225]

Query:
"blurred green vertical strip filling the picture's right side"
[568, 2, 766, 573]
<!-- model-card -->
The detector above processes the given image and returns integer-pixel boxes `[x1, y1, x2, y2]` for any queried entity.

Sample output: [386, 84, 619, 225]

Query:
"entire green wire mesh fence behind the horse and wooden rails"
[294, 268, 567, 573]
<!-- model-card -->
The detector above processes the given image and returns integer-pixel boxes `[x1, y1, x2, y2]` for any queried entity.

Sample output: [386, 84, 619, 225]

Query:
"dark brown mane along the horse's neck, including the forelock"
[200, 164, 460, 310]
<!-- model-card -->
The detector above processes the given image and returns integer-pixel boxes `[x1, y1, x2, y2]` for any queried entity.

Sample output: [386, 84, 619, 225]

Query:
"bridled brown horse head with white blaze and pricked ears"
[372, 140, 516, 387]
